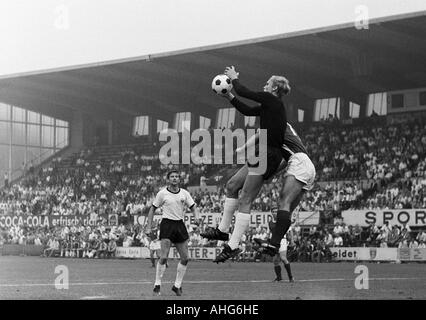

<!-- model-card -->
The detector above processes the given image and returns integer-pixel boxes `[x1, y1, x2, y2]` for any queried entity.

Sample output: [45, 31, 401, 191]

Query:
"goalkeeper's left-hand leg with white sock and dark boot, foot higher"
[201, 165, 248, 241]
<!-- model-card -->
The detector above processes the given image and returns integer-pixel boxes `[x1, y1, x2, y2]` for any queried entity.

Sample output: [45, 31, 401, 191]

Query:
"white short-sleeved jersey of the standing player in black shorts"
[152, 187, 195, 220]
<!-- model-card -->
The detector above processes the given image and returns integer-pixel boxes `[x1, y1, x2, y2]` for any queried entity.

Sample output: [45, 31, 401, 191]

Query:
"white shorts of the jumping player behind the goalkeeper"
[284, 152, 316, 191]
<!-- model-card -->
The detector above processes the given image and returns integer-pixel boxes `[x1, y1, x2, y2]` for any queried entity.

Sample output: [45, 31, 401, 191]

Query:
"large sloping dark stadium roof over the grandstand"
[0, 11, 426, 121]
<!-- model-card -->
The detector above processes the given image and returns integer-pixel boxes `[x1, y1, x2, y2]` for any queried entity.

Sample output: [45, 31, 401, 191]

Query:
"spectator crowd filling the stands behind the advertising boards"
[0, 117, 426, 259]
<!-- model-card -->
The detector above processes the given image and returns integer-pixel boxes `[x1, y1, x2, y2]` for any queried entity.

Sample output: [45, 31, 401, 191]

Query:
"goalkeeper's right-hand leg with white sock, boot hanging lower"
[213, 174, 263, 263]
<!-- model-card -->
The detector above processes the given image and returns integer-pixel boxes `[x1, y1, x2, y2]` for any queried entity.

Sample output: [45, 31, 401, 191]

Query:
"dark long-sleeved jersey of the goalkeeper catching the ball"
[231, 79, 287, 149]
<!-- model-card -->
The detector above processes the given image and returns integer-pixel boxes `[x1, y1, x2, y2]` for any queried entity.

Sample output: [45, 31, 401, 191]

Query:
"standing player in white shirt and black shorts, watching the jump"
[145, 170, 199, 296]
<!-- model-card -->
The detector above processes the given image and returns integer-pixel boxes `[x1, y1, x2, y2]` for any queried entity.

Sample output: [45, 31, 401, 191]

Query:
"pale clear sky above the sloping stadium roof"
[0, 0, 426, 78]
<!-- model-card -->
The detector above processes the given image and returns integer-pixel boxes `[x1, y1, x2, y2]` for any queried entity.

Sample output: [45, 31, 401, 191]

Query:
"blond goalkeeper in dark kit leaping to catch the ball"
[202, 67, 290, 263]
